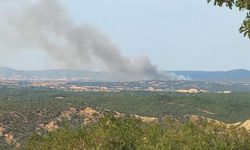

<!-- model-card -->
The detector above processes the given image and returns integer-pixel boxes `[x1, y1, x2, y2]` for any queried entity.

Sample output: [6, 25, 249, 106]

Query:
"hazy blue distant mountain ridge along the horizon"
[0, 67, 250, 82]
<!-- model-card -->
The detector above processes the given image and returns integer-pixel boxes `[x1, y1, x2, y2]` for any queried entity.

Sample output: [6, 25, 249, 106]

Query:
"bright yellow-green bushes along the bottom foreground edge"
[25, 116, 250, 150]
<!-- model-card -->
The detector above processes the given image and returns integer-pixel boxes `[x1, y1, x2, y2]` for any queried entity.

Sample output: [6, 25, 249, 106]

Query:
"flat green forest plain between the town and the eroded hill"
[0, 88, 250, 122]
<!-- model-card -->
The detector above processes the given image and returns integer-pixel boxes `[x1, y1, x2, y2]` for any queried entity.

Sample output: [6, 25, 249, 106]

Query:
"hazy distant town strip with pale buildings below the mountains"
[0, 76, 242, 94]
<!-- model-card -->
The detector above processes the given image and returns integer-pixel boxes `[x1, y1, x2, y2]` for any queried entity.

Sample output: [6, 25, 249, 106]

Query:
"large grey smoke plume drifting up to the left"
[0, 0, 181, 80]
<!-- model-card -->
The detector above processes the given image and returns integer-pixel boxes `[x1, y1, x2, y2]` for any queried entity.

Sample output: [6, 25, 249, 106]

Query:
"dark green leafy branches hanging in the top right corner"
[208, 0, 250, 38]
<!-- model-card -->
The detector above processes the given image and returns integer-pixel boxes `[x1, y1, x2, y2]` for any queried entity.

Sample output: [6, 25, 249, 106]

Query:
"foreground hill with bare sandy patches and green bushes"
[1, 107, 250, 150]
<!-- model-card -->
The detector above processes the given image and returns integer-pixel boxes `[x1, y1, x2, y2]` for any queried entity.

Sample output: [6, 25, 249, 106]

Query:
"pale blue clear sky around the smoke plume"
[0, 0, 250, 71]
